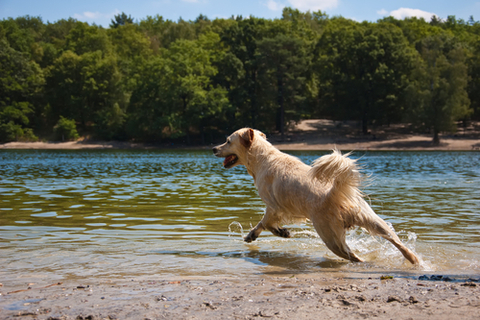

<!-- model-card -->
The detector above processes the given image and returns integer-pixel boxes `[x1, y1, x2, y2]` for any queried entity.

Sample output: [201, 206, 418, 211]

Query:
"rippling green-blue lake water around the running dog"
[0, 150, 480, 284]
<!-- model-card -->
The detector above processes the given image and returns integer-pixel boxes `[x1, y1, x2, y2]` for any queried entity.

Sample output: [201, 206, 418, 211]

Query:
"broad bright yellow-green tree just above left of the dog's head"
[127, 33, 228, 143]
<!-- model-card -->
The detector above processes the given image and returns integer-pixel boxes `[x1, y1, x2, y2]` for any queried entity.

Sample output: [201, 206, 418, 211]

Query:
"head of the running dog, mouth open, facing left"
[213, 128, 267, 169]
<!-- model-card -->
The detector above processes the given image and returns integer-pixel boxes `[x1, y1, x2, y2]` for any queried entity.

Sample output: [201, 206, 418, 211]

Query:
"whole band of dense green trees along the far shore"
[0, 8, 480, 143]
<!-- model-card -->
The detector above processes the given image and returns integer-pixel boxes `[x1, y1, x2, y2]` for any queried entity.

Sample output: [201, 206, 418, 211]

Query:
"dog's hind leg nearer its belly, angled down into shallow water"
[312, 220, 363, 262]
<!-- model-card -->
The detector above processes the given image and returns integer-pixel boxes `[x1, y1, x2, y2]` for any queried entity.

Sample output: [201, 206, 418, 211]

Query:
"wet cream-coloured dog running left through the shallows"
[213, 128, 419, 265]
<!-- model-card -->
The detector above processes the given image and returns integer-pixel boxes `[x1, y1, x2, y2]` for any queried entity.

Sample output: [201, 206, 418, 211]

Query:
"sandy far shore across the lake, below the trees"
[0, 120, 480, 151]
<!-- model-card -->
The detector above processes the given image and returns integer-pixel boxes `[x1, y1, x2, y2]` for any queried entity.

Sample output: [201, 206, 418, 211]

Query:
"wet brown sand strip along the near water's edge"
[0, 275, 480, 319]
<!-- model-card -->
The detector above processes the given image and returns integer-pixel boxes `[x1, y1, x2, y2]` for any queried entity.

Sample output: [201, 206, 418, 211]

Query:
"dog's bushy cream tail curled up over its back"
[309, 150, 362, 209]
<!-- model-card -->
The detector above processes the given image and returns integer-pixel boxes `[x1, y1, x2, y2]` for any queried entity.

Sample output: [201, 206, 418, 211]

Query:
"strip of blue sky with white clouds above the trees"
[0, 0, 480, 27]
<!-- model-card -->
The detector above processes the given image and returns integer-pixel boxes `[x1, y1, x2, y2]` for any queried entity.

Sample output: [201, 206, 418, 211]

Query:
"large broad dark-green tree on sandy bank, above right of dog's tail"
[316, 19, 414, 134]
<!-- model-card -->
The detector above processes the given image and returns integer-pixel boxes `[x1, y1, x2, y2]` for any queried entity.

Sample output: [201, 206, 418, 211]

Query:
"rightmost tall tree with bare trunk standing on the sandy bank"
[410, 33, 472, 145]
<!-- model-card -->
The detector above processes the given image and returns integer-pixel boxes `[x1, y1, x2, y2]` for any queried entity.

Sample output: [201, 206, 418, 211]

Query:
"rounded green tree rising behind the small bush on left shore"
[47, 51, 125, 135]
